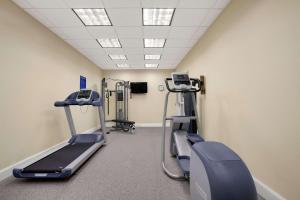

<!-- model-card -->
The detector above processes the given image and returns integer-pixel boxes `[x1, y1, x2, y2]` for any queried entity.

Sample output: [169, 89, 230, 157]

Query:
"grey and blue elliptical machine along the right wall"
[161, 73, 257, 200]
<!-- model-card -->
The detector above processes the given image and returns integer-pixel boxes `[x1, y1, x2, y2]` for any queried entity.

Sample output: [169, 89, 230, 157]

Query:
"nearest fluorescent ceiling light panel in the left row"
[73, 8, 111, 26]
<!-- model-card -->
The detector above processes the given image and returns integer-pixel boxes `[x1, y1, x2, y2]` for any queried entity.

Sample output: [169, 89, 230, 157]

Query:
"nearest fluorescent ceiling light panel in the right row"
[143, 8, 175, 26]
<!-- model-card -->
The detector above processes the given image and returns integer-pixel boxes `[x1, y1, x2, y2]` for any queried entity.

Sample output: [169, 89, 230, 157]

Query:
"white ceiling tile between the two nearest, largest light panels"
[106, 8, 142, 26]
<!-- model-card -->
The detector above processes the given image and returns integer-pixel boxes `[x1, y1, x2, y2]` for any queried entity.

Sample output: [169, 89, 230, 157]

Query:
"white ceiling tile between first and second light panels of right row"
[143, 26, 171, 38]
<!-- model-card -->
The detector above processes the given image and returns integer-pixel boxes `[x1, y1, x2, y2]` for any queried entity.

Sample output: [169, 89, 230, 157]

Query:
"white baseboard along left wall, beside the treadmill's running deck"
[0, 140, 68, 181]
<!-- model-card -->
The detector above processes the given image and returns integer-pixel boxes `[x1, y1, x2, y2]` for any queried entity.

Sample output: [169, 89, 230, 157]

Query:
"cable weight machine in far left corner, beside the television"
[101, 78, 135, 133]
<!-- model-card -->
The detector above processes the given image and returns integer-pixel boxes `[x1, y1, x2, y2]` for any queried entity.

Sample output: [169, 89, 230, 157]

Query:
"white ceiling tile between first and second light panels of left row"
[86, 26, 117, 38]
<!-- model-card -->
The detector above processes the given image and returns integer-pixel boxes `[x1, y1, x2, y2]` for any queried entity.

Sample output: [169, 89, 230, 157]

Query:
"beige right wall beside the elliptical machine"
[177, 0, 300, 200]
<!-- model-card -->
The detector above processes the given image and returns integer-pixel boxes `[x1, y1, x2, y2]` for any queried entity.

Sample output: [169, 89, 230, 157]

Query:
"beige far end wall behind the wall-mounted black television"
[103, 70, 175, 123]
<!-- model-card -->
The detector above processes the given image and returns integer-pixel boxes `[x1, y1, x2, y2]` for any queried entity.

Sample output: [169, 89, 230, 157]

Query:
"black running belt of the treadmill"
[23, 143, 95, 173]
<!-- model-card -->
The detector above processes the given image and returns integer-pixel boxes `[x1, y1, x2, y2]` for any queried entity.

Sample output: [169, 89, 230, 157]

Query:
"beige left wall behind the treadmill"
[0, 0, 101, 169]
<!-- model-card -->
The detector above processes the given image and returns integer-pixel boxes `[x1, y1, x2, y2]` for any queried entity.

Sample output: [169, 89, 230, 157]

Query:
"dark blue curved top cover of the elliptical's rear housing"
[192, 142, 257, 200]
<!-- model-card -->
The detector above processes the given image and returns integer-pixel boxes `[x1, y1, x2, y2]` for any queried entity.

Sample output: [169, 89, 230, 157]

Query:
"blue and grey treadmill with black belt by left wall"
[13, 90, 106, 179]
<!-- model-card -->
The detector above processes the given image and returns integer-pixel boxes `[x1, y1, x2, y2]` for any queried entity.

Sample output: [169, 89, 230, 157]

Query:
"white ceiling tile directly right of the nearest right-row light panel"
[172, 9, 208, 26]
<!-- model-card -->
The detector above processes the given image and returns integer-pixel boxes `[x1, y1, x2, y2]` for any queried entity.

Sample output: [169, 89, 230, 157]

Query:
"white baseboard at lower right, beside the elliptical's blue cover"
[253, 177, 286, 200]
